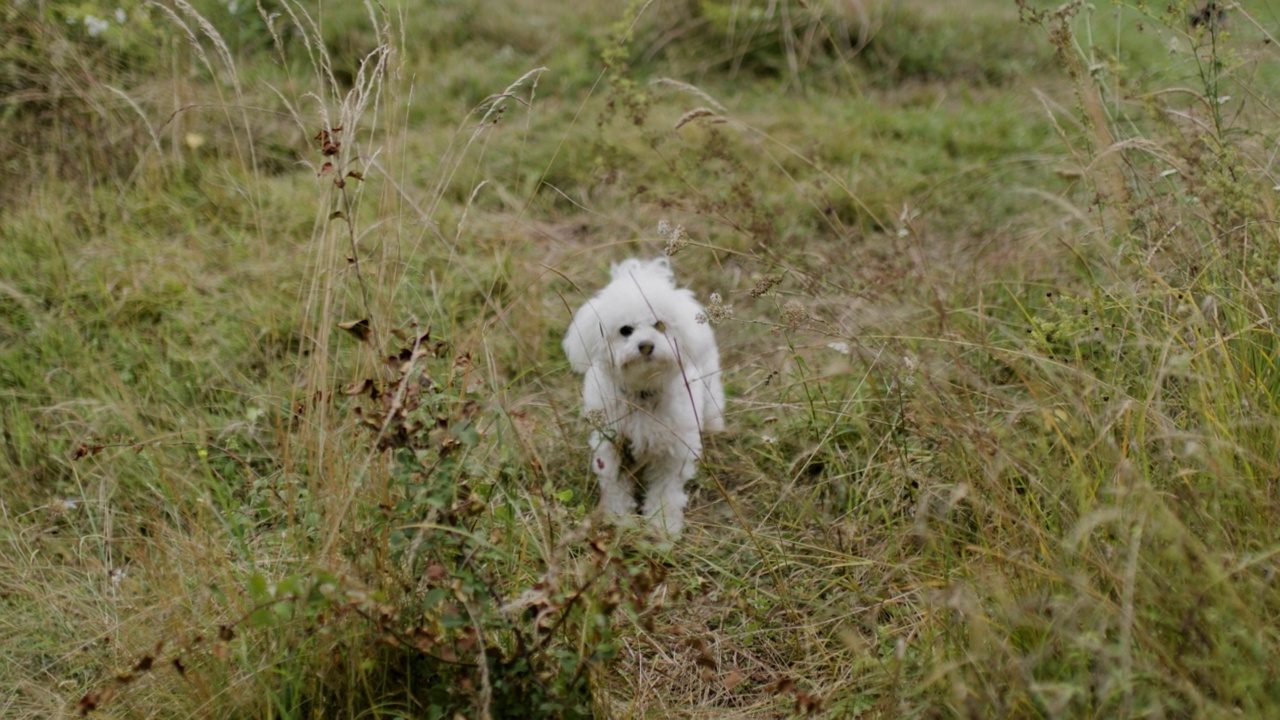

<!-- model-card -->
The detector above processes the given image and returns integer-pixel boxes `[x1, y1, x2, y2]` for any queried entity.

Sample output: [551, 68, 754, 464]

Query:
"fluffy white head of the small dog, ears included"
[564, 258, 703, 391]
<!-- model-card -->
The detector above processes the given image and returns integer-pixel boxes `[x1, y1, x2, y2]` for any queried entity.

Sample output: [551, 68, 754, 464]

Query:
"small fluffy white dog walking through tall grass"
[564, 258, 724, 536]
